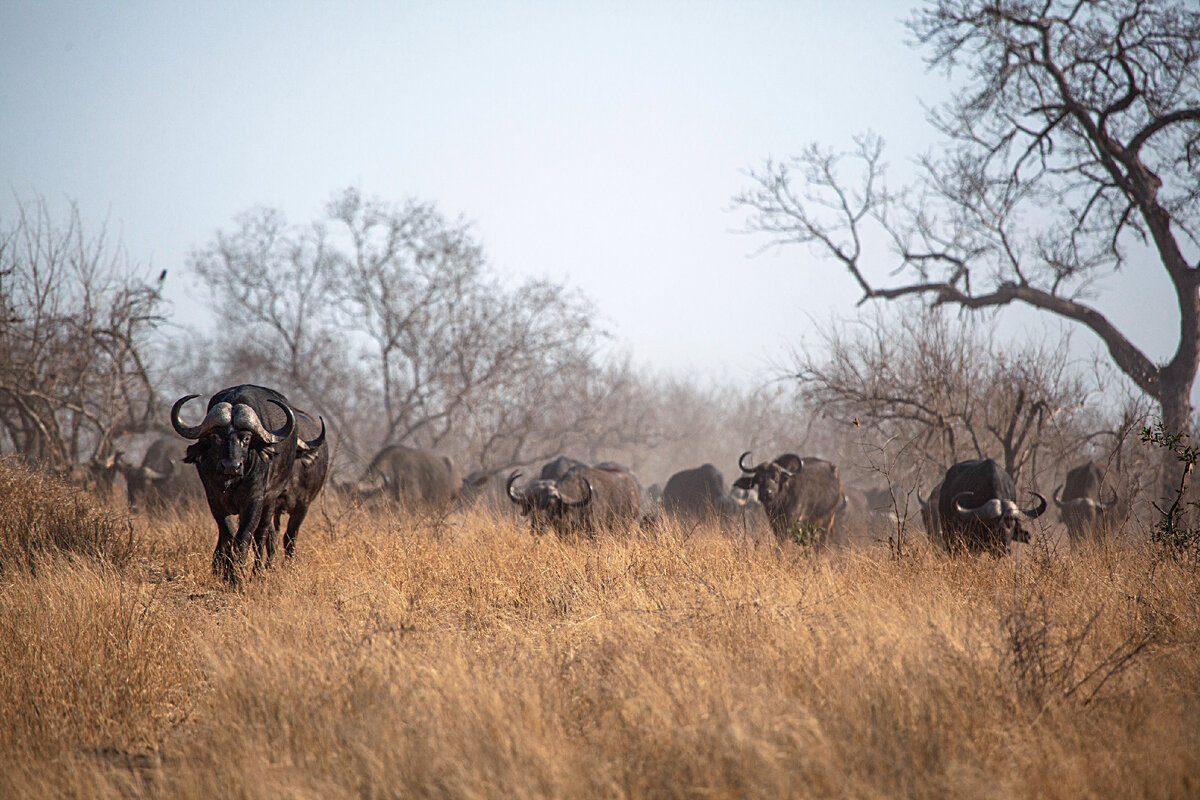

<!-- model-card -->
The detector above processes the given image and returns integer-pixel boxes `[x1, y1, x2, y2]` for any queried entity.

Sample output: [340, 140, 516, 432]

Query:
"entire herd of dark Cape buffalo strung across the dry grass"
[51, 376, 1104, 583]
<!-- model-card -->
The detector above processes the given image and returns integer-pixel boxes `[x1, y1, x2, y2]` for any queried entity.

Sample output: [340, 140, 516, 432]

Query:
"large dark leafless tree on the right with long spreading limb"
[736, 0, 1200, 441]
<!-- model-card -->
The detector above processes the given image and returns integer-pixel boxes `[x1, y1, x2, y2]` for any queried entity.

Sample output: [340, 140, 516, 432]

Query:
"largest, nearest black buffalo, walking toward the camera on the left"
[170, 385, 324, 583]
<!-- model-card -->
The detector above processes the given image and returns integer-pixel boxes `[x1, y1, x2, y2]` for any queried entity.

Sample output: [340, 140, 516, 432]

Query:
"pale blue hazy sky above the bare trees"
[0, 0, 1177, 388]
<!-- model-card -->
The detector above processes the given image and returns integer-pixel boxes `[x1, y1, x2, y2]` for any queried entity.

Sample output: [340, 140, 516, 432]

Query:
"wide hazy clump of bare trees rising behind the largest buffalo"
[192, 188, 642, 468]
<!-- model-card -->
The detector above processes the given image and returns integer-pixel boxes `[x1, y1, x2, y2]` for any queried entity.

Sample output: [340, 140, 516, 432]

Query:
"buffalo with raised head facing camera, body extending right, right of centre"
[733, 451, 842, 545]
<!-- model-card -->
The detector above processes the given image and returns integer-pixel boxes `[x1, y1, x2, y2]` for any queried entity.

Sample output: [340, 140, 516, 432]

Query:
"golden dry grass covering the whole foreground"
[0, 464, 1200, 799]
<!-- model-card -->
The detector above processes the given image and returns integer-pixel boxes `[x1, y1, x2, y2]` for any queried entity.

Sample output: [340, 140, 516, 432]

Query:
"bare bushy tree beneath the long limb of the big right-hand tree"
[796, 304, 1097, 479]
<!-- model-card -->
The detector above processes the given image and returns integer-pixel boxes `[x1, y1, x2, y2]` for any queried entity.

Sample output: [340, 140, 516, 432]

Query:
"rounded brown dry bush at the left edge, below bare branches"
[0, 458, 133, 575]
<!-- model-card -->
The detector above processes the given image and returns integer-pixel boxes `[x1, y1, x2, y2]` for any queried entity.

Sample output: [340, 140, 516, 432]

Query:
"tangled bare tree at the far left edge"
[0, 198, 163, 469]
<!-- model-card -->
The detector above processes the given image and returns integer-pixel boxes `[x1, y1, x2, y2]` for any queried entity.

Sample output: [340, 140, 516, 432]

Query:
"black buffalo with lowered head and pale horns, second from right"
[937, 458, 1046, 554]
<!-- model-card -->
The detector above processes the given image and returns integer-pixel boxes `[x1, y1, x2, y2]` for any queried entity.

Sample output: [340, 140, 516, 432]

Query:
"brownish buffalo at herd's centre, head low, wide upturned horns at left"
[506, 464, 642, 536]
